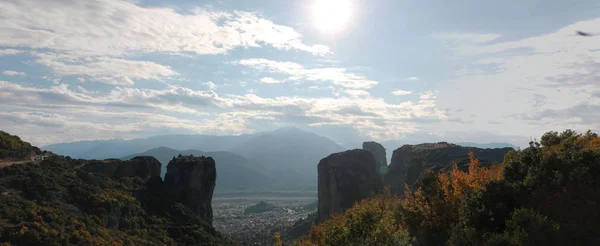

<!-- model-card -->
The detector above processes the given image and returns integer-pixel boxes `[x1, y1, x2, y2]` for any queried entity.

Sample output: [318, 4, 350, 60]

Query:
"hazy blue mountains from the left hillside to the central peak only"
[44, 127, 346, 186]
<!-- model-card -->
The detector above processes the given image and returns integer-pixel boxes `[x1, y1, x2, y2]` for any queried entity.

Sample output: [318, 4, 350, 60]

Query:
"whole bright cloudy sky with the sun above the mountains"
[0, 0, 600, 146]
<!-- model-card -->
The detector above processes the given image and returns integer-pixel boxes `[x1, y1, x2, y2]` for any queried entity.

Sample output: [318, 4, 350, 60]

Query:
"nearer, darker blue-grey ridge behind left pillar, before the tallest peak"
[120, 147, 273, 190]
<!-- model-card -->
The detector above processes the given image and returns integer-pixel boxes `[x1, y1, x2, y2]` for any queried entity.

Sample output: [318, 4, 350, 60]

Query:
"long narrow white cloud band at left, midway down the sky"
[0, 81, 226, 114]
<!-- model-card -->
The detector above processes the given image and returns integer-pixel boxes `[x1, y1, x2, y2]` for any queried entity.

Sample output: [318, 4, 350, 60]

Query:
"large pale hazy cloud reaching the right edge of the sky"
[436, 19, 600, 136]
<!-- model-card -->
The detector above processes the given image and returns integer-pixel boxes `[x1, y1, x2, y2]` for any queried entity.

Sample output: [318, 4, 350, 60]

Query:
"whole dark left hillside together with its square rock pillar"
[0, 136, 239, 245]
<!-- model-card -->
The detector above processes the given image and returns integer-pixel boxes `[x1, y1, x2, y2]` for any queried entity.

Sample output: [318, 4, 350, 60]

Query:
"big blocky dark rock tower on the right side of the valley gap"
[317, 149, 383, 222]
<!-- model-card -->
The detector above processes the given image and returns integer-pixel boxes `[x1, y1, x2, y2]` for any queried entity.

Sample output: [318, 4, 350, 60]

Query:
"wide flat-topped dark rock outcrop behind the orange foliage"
[384, 142, 512, 195]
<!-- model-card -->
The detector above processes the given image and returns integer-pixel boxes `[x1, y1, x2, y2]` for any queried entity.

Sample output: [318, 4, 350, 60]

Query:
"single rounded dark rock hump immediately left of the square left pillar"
[113, 156, 161, 178]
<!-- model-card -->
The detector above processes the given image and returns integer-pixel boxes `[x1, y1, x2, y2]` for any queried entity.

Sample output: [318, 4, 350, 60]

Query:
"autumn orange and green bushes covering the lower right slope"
[296, 130, 600, 245]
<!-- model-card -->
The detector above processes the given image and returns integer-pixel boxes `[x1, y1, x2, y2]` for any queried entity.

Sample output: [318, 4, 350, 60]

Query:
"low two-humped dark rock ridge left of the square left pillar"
[83, 156, 161, 179]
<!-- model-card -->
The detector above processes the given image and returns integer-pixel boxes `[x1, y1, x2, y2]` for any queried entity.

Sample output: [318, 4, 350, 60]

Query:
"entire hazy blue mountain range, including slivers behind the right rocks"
[43, 127, 517, 189]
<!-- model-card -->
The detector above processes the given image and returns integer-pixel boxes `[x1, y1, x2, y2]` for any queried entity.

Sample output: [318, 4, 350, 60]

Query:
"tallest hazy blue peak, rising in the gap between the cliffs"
[231, 127, 344, 184]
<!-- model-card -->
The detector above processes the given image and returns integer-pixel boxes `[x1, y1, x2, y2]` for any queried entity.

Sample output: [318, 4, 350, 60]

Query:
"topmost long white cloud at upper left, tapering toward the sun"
[0, 0, 330, 56]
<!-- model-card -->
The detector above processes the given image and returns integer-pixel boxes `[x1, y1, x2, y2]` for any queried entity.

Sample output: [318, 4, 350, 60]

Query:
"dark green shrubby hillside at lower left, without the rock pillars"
[0, 156, 236, 245]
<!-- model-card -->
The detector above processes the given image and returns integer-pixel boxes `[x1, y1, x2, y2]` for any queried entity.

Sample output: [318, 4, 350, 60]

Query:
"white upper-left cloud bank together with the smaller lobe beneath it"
[0, 0, 331, 85]
